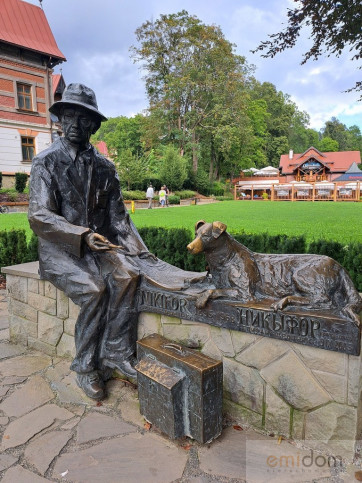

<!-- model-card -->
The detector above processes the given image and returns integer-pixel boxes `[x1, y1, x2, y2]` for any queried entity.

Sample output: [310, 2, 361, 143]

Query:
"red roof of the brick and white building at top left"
[0, 0, 66, 61]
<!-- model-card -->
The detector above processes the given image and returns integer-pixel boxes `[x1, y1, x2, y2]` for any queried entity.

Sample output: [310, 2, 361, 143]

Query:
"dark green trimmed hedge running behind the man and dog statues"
[0, 227, 362, 292]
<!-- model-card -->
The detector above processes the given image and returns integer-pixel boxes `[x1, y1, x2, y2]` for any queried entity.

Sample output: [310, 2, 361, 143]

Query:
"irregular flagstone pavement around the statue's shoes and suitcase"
[0, 290, 359, 483]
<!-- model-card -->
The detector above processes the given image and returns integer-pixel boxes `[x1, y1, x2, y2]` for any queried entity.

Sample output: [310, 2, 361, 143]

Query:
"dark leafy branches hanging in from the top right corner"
[253, 0, 362, 97]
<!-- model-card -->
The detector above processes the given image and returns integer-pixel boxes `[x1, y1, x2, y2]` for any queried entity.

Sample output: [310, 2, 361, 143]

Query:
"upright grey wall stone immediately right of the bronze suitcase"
[223, 357, 264, 413]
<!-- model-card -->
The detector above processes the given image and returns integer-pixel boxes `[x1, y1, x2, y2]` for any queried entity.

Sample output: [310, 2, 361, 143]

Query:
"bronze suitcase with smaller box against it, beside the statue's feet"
[136, 334, 222, 443]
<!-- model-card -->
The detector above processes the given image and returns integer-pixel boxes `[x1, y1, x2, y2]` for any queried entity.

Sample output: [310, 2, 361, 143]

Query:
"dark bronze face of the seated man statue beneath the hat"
[60, 106, 94, 146]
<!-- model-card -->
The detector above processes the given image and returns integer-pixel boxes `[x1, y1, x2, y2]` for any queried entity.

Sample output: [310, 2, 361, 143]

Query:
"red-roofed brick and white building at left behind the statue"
[0, 0, 66, 187]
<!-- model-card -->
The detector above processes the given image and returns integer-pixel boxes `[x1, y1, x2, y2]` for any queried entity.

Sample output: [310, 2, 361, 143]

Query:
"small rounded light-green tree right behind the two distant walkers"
[159, 145, 187, 190]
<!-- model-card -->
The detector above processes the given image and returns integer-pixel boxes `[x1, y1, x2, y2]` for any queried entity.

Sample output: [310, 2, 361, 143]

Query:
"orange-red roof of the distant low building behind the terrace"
[280, 147, 361, 178]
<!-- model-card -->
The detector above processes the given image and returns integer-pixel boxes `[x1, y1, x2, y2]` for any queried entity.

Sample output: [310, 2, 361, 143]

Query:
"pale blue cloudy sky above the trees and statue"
[28, 0, 362, 130]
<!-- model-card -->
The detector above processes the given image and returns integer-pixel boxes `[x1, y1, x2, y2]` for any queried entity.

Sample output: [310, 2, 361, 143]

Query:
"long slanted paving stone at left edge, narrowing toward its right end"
[1, 404, 73, 450]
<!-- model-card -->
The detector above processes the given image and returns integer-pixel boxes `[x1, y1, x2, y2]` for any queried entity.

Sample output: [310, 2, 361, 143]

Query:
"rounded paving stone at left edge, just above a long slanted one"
[0, 376, 54, 417]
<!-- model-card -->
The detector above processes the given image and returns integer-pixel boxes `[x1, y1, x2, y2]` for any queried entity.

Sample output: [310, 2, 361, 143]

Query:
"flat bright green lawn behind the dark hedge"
[0, 201, 362, 243]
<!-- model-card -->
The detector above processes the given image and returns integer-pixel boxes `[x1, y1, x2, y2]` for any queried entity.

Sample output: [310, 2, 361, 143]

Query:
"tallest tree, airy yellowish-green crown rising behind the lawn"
[131, 10, 253, 173]
